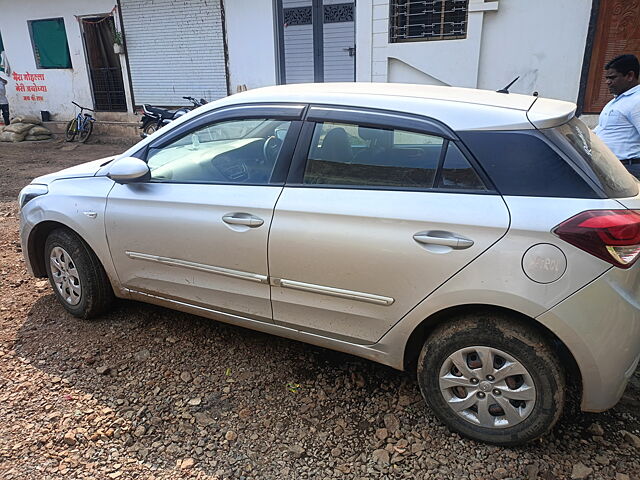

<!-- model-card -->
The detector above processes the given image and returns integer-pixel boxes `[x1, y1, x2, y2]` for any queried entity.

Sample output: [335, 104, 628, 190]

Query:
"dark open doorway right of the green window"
[82, 15, 127, 112]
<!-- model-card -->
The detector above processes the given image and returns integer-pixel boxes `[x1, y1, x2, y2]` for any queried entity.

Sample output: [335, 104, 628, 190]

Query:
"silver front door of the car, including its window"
[105, 105, 304, 322]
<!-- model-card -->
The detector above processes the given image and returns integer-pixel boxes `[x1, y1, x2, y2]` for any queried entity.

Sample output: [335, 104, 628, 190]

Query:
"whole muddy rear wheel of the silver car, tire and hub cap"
[417, 313, 565, 446]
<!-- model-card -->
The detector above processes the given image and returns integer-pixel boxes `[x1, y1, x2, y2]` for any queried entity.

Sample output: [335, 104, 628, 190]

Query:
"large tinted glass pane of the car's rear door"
[303, 122, 444, 188]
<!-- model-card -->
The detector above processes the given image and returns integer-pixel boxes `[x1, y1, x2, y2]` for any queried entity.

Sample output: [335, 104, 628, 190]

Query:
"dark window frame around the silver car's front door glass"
[132, 104, 307, 187]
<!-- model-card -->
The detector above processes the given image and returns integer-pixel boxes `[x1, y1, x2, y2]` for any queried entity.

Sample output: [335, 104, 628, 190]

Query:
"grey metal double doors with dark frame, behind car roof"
[277, 0, 356, 84]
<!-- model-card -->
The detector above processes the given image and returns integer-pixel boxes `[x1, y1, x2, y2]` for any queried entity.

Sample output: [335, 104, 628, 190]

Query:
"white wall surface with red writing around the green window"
[0, 0, 130, 120]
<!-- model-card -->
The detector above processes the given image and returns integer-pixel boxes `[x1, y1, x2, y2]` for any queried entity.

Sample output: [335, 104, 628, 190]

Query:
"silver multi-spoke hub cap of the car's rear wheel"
[439, 346, 536, 428]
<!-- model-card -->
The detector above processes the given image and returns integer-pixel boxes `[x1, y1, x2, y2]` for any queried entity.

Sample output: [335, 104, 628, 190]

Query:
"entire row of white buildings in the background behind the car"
[0, 0, 640, 127]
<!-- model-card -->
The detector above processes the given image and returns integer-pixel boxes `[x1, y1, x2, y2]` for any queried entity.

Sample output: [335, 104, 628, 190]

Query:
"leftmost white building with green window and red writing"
[0, 0, 133, 121]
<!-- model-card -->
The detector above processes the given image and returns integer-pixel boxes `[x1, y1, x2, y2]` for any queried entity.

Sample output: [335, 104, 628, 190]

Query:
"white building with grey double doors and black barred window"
[225, 0, 640, 117]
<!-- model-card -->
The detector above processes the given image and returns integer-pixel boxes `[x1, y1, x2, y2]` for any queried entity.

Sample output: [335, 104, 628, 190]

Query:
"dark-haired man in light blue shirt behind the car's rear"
[594, 54, 640, 178]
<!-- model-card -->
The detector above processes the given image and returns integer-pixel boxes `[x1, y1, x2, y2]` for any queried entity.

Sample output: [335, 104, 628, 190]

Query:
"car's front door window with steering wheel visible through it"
[147, 118, 291, 184]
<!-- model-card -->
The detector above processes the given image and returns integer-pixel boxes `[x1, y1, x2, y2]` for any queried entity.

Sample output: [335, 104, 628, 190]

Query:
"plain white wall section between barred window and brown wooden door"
[478, 0, 592, 102]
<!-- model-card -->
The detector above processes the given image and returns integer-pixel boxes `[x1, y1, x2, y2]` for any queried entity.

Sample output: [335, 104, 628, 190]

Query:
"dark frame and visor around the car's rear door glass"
[285, 104, 499, 195]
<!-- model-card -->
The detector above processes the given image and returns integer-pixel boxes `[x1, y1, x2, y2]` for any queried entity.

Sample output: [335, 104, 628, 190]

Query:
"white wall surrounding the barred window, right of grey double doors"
[356, 0, 592, 102]
